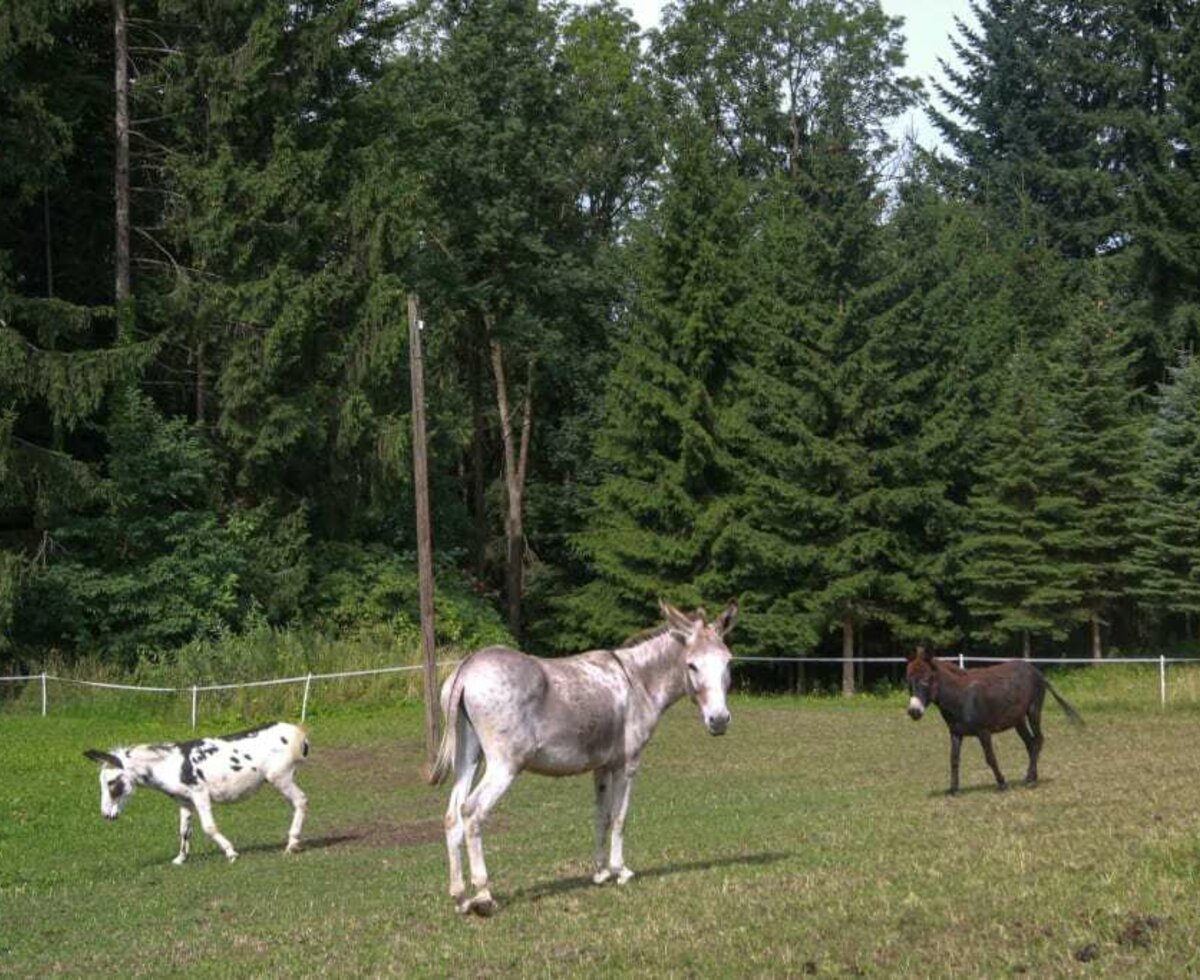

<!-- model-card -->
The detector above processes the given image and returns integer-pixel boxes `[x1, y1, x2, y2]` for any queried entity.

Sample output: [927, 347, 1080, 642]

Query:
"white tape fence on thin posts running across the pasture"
[0, 654, 1200, 731]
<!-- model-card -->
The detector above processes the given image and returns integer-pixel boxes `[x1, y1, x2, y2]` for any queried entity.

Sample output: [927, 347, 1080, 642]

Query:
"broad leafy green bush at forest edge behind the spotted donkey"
[14, 389, 250, 666]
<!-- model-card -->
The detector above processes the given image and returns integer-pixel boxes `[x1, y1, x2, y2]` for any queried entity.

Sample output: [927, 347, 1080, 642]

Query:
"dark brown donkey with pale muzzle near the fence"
[907, 647, 1084, 795]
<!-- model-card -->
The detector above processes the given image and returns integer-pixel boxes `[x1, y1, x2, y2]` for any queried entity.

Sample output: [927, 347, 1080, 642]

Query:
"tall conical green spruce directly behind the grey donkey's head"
[563, 118, 749, 645]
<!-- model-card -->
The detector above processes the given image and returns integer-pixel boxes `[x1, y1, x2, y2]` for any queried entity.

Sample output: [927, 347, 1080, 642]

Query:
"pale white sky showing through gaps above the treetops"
[623, 0, 974, 146]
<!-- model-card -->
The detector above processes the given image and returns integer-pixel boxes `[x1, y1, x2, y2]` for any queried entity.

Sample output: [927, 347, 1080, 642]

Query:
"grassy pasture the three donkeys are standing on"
[0, 671, 1200, 976]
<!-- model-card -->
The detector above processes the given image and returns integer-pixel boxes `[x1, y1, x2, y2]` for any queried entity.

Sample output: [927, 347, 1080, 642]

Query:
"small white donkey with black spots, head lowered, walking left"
[84, 721, 308, 865]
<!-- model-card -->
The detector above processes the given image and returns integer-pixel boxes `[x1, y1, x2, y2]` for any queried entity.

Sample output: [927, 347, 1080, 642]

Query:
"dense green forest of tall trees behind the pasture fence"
[0, 0, 1200, 686]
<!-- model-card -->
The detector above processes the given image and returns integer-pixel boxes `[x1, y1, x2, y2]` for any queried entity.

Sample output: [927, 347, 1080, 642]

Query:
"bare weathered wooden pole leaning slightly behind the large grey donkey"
[408, 293, 442, 768]
